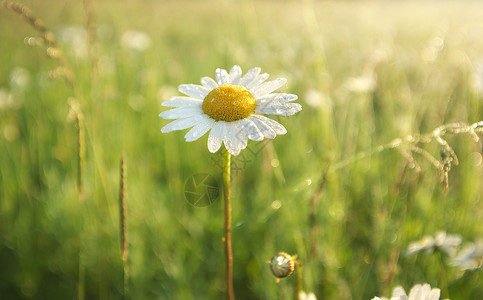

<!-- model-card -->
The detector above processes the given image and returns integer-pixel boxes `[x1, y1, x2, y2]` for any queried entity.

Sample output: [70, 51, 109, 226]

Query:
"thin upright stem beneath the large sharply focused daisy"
[223, 149, 235, 300]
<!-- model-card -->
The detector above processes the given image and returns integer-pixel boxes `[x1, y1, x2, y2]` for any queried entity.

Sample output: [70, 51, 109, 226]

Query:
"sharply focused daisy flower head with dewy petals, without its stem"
[159, 65, 302, 155]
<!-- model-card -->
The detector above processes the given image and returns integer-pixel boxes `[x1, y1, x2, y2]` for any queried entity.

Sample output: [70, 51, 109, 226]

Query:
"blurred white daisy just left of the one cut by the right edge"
[406, 231, 462, 256]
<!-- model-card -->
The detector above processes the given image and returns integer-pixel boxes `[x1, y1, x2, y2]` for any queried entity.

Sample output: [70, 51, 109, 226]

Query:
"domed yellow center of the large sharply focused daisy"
[202, 84, 257, 122]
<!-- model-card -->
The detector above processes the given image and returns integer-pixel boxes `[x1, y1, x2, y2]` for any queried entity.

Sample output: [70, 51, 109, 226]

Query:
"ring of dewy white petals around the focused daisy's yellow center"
[159, 65, 302, 155]
